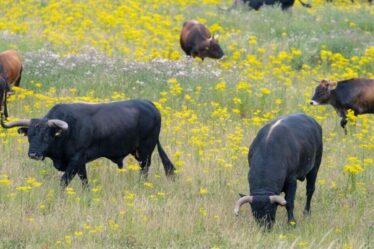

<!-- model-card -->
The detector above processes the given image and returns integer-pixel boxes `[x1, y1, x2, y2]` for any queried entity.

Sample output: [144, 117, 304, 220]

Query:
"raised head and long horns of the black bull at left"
[1, 117, 69, 160]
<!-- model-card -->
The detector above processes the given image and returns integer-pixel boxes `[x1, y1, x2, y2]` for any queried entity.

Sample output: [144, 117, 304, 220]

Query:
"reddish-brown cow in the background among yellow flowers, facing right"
[180, 20, 224, 60]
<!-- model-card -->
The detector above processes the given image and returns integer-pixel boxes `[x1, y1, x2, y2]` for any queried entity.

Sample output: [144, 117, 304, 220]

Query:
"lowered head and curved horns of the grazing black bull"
[234, 195, 287, 229]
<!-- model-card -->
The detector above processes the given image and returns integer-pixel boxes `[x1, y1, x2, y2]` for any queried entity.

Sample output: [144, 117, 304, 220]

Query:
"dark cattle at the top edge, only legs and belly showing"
[220, 0, 312, 10]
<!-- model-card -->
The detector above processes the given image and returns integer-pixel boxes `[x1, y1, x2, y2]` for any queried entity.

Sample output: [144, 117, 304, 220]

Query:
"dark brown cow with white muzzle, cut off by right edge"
[310, 78, 374, 134]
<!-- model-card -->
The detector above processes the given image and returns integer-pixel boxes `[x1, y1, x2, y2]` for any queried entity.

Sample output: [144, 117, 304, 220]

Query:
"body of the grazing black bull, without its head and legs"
[248, 114, 322, 192]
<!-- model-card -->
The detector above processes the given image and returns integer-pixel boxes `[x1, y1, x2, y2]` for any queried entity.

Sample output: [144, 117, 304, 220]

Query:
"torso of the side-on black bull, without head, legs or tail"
[45, 100, 161, 161]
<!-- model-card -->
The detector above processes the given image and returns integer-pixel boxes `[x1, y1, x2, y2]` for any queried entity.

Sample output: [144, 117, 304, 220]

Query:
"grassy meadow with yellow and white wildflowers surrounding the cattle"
[0, 0, 374, 249]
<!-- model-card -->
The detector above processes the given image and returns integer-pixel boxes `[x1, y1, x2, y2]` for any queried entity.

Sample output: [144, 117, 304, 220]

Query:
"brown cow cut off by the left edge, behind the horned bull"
[0, 50, 22, 117]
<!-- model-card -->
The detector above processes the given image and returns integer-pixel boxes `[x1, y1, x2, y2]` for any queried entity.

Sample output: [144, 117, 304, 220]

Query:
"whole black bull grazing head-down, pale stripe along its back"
[234, 114, 322, 228]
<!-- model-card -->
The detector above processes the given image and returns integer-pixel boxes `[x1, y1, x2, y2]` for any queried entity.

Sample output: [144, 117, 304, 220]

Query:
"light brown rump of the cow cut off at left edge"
[0, 50, 22, 86]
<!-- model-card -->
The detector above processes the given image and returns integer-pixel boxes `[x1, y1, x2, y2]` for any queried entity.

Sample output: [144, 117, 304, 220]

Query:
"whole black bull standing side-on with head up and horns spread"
[1, 100, 175, 187]
